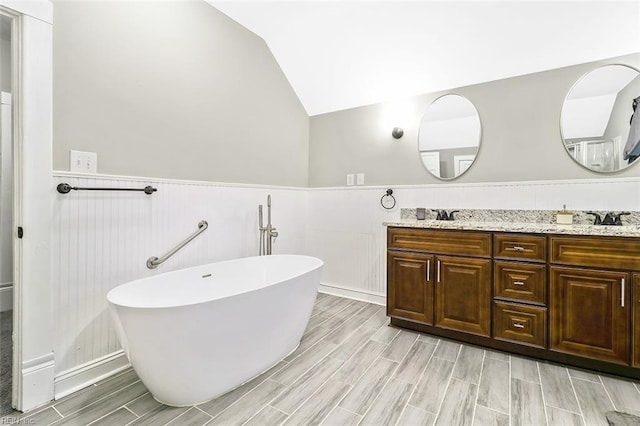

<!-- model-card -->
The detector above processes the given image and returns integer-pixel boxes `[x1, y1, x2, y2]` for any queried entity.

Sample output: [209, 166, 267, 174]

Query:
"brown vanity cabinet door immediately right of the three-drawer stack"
[549, 267, 630, 364]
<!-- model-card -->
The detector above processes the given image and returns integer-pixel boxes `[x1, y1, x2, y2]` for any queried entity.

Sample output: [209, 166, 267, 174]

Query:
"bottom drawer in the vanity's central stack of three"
[493, 302, 547, 348]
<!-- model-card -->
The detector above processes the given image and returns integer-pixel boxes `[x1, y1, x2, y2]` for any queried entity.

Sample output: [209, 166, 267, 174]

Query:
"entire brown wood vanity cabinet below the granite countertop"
[387, 227, 640, 379]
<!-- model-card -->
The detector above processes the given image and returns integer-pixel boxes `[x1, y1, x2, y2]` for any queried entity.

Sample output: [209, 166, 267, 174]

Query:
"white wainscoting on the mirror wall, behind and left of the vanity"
[307, 178, 640, 304]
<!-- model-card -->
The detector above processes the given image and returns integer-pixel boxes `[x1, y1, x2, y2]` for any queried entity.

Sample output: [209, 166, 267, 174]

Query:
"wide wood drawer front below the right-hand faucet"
[549, 235, 640, 271]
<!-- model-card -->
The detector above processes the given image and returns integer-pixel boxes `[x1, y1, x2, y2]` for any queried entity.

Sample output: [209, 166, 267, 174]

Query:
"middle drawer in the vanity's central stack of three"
[493, 261, 547, 305]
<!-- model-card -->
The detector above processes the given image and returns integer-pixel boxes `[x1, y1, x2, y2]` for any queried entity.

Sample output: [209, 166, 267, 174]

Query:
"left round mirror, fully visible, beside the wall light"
[418, 95, 480, 179]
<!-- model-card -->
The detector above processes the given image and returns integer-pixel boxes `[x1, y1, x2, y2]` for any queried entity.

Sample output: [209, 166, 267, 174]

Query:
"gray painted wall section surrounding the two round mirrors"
[309, 53, 640, 187]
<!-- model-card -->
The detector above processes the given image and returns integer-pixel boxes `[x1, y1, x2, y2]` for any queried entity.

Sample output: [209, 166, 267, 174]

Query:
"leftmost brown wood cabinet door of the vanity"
[387, 250, 433, 325]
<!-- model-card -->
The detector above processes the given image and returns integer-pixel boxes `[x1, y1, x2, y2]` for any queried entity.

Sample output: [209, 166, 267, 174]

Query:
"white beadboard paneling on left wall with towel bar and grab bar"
[52, 173, 307, 376]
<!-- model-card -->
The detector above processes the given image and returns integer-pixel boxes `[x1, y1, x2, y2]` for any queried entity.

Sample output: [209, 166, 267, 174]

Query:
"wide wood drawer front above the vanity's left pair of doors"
[387, 227, 491, 257]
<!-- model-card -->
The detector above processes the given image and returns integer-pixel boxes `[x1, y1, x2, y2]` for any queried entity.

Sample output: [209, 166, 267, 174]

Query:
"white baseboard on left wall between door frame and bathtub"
[54, 350, 131, 399]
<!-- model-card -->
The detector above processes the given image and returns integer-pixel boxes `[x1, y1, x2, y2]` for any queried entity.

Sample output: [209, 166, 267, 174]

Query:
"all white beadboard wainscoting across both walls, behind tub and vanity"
[52, 172, 640, 398]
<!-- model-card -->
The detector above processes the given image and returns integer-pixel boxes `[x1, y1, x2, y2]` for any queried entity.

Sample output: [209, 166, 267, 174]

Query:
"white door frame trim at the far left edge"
[0, 0, 55, 411]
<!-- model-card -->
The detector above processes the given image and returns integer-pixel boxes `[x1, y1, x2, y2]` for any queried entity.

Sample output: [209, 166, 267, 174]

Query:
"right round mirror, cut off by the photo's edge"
[560, 65, 640, 172]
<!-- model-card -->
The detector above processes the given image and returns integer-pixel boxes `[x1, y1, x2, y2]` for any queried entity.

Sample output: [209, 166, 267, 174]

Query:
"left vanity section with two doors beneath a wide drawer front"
[387, 227, 491, 336]
